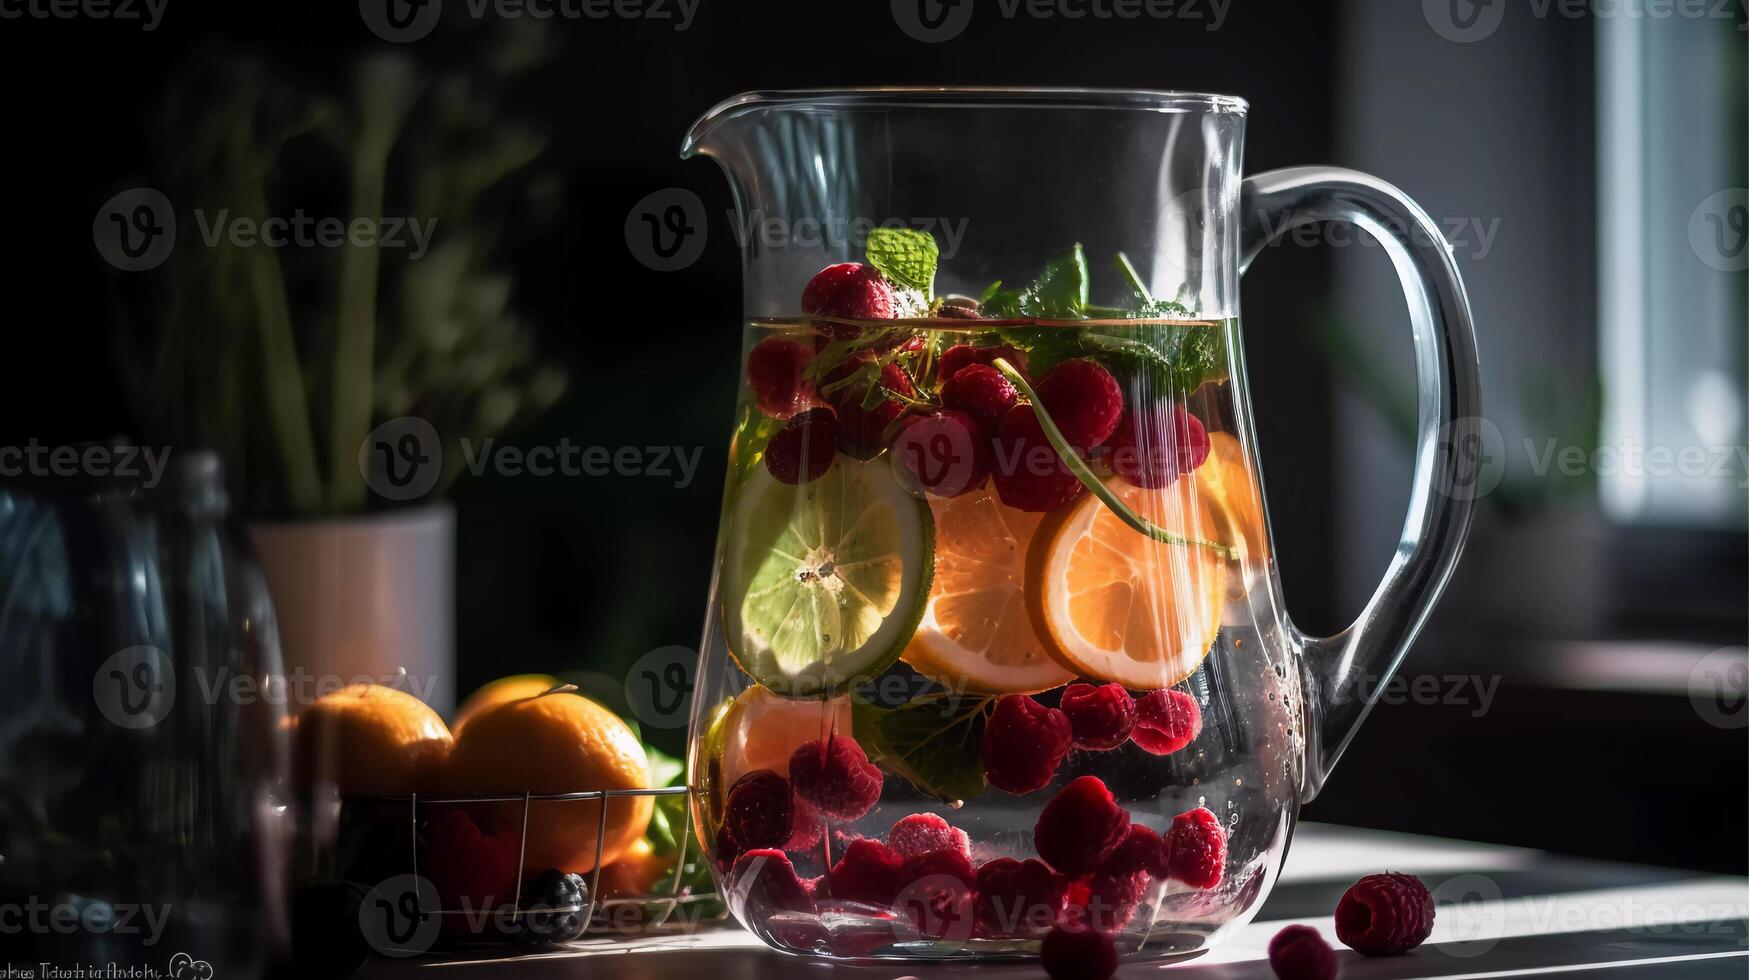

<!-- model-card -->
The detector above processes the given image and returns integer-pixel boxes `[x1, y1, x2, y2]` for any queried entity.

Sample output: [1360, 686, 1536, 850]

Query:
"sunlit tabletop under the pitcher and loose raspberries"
[364, 824, 1749, 980]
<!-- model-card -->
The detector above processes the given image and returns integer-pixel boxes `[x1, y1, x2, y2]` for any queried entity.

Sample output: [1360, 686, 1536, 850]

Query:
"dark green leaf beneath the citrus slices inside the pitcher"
[850, 697, 993, 803]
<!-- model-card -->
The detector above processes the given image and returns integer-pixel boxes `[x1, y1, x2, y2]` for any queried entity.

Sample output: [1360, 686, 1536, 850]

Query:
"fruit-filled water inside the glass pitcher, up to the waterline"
[693, 266, 1300, 959]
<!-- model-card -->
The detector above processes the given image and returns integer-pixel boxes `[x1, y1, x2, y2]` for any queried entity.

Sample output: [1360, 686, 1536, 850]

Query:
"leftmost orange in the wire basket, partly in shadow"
[294, 684, 451, 796]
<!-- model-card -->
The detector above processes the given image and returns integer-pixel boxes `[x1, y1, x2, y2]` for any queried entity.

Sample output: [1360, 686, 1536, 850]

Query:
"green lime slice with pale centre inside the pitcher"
[722, 457, 936, 697]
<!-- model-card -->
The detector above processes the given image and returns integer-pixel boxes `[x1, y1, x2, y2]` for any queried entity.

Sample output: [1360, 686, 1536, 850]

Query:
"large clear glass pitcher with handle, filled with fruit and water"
[682, 89, 1480, 959]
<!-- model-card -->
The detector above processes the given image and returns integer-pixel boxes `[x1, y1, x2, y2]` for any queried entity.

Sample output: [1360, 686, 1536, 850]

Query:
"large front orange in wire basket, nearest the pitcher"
[444, 691, 654, 873]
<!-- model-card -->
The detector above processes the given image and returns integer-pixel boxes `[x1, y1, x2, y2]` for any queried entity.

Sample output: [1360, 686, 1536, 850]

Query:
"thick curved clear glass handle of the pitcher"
[1240, 166, 1481, 803]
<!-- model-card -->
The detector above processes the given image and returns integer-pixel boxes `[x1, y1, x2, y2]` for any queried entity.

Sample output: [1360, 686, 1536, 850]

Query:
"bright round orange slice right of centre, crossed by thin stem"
[1027, 478, 1226, 691]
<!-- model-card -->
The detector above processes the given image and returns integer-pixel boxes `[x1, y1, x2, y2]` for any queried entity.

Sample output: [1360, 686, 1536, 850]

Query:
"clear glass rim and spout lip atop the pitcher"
[680, 86, 1249, 158]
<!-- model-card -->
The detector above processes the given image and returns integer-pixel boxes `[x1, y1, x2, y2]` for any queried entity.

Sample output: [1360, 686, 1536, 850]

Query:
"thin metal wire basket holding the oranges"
[343, 786, 728, 942]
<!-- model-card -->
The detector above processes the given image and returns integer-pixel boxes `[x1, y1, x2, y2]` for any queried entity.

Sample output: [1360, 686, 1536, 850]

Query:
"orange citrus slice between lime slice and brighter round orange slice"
[904, 488, 1074, 695]
